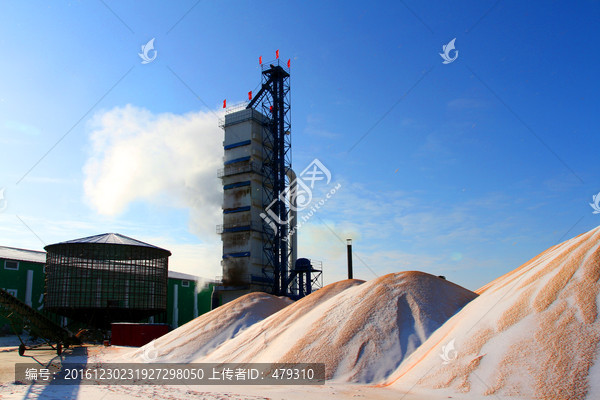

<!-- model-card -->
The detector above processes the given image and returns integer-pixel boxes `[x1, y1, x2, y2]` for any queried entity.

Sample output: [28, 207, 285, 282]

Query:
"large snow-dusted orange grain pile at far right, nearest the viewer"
[387, 227, 600, 399]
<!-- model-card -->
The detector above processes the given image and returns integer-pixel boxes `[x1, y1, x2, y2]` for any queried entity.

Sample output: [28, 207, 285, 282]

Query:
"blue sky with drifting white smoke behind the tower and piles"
[0, 0, 600, 289]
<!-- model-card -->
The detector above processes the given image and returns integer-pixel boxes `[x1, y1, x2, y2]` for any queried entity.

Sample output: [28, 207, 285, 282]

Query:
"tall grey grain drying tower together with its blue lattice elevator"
[217, 59, 320, 301]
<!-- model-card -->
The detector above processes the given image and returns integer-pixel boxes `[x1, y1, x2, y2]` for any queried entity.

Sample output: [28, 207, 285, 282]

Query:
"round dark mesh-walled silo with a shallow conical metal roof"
[44, 233, 171, 328]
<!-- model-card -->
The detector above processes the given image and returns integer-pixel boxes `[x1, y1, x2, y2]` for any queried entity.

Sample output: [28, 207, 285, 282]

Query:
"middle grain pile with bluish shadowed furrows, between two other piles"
[195, 272, 477, 382]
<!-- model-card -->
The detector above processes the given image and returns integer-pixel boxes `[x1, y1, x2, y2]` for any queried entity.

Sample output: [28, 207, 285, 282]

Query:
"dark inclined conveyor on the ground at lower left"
[0, 289, 80, 356]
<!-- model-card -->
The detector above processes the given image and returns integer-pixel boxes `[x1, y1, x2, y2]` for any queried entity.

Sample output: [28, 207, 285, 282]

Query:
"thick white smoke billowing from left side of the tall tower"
[83, 105, 223, 237]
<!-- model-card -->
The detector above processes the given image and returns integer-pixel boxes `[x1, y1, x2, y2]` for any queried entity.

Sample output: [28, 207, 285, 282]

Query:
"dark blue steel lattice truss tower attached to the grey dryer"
[246, 60, 293, 296]
